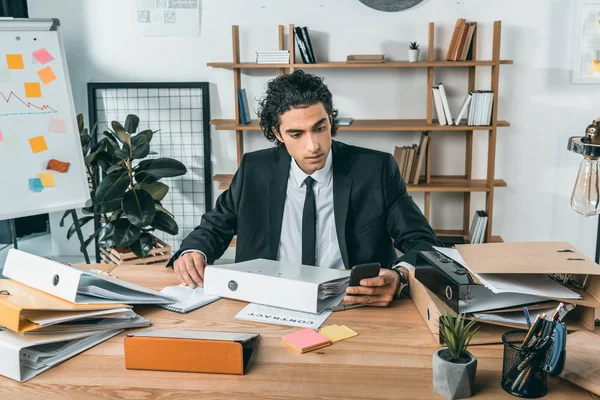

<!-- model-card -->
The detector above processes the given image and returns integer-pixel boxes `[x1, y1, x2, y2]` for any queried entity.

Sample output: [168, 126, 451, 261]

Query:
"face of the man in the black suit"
[275, 103, 331, 175]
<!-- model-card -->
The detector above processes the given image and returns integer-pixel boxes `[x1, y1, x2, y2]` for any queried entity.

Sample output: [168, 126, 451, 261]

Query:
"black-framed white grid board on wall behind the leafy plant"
[88, 82, 212, 258]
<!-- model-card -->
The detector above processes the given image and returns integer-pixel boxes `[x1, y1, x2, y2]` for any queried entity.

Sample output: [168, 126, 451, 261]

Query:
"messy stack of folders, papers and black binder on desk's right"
[411, 242, 600, 344]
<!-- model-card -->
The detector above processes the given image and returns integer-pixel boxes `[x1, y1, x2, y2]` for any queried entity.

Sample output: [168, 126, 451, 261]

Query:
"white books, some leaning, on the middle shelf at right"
[432, 83, 494, 126]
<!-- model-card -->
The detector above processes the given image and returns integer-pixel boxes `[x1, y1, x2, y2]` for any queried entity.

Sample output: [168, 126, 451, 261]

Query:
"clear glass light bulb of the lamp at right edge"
[571, 157, 600, 217]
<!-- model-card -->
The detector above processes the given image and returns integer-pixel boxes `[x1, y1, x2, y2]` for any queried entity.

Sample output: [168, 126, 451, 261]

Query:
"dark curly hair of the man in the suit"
[258, 69, 338, 148]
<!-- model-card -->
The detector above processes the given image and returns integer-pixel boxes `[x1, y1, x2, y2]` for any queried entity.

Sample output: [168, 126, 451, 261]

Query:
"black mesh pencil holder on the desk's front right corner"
[502, 330, 551, 398]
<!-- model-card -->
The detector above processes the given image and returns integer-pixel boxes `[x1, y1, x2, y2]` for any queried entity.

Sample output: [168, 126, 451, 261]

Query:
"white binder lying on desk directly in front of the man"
[204, 259, 350, 314]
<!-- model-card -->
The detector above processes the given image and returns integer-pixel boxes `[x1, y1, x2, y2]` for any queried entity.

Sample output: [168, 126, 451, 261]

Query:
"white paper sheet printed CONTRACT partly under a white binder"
[235, 303, 331, 329]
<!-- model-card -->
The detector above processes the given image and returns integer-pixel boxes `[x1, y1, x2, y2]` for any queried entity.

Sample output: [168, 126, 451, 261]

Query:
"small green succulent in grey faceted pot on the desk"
[433, 310, 479, 399]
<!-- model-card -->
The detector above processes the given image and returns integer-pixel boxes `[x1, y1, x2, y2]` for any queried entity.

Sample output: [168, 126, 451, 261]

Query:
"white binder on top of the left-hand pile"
[3, 249, 176, 304]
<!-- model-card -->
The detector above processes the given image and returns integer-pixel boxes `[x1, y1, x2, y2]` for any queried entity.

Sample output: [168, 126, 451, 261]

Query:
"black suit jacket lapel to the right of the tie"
[332, 141, 352, 268]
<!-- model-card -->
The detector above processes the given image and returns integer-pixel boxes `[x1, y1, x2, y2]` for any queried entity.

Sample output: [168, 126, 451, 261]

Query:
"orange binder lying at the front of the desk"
[124, 330, 260, 375]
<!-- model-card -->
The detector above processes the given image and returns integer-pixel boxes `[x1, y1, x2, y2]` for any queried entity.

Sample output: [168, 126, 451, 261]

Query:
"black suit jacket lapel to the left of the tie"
[267, 150, 291, 260]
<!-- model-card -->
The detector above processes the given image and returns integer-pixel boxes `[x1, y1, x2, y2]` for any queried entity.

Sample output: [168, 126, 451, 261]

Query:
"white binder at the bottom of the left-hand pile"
[0, 327, 123, 382]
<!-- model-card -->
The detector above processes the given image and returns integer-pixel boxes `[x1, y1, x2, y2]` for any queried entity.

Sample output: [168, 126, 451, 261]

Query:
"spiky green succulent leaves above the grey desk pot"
[438, 309, 479, 362]
